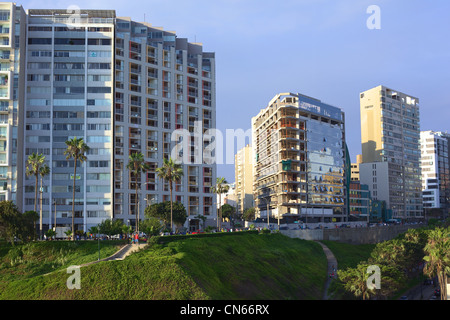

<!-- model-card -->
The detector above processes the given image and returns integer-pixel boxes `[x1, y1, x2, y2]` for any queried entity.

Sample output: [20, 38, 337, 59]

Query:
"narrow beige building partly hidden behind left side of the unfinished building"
[234, 145, 253, 214]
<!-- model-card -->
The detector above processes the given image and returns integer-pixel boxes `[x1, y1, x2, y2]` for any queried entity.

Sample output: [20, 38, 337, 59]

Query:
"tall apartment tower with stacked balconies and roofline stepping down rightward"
[113, 18, 216, 230]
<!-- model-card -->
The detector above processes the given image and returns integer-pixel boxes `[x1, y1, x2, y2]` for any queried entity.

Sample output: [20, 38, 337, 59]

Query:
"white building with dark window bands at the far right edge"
[420, 131, 450, 214]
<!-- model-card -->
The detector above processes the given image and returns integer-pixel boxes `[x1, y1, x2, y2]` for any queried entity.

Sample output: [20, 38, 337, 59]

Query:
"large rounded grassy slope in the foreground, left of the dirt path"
[0, 233, 327, 300]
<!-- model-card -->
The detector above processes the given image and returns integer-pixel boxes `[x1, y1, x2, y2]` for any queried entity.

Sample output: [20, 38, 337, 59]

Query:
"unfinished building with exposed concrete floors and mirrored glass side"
[252, 93, 350, 223]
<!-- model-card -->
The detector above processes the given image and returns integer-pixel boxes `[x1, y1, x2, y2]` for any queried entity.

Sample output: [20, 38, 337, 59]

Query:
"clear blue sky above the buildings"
[17, 0, 450, 182]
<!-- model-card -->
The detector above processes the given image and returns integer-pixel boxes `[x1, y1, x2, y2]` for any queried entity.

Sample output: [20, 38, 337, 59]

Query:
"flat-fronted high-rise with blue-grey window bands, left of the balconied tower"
[22, 9, 116, 231]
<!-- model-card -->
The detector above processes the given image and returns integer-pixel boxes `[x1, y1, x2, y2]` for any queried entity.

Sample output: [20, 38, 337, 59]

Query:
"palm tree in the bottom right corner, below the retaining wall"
[424, 228, 450, 300]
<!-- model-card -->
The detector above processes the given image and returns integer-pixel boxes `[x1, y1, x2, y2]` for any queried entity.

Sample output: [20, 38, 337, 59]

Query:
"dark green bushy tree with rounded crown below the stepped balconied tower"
[145, 201, 187, 231]
